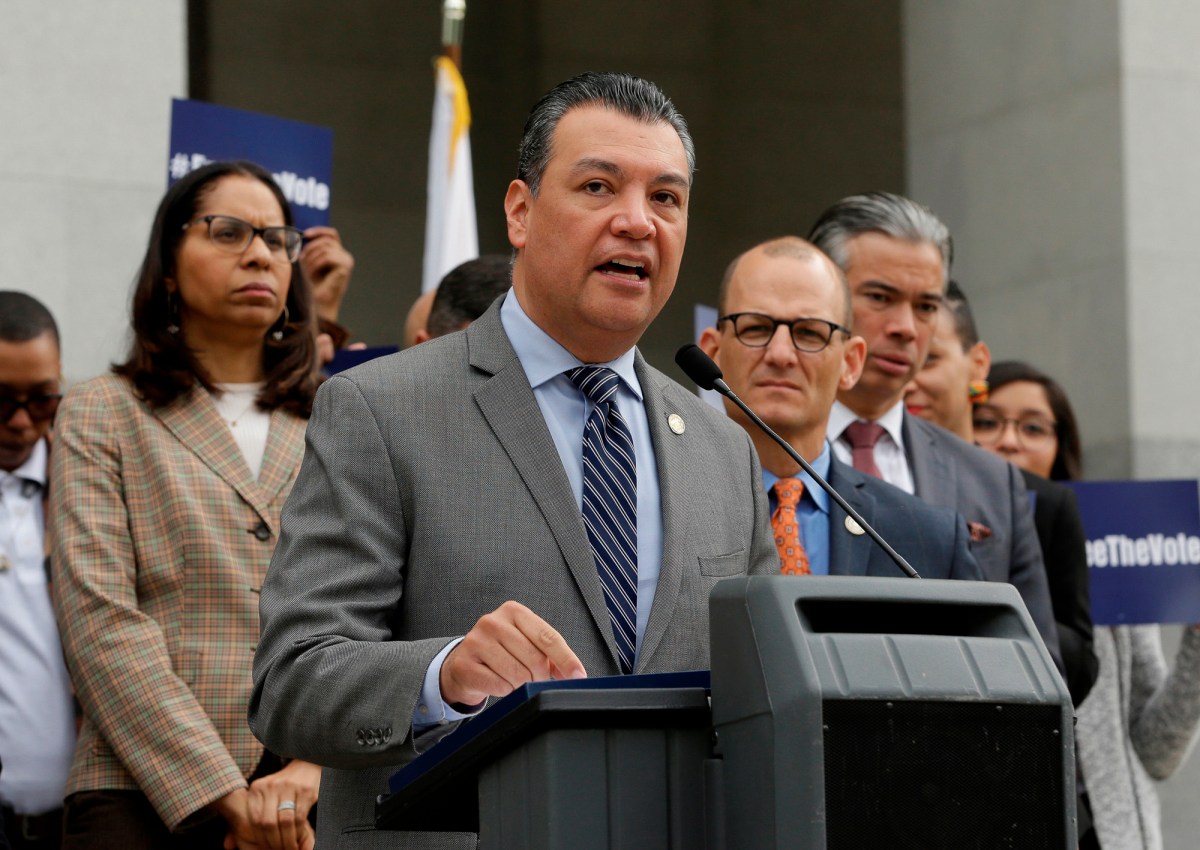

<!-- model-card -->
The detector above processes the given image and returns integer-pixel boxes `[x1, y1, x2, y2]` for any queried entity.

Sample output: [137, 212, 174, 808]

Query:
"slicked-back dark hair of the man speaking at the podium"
[517, 71, 696, 197]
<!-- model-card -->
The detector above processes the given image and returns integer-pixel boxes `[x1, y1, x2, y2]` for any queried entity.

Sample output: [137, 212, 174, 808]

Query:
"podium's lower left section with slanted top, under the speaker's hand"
[377, 671, 712, 850]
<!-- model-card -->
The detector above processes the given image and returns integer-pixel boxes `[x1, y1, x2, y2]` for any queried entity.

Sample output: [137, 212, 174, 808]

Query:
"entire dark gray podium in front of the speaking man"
[377, 576, 1075, 850]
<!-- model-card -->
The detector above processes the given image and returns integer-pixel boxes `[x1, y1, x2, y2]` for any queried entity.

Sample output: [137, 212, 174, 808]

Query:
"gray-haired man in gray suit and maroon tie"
[809, 192, 1062, 670]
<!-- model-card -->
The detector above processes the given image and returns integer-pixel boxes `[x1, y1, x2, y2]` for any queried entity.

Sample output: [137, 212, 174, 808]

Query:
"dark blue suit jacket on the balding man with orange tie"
[829, 457, 983, 581]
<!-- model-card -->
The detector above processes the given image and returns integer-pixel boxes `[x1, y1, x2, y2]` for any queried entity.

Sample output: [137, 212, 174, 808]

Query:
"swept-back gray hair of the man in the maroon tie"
[809, 192, 954, 288]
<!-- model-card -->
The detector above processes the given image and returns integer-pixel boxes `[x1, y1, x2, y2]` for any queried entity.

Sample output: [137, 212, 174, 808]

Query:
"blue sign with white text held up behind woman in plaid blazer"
[167, 98, 334, 229]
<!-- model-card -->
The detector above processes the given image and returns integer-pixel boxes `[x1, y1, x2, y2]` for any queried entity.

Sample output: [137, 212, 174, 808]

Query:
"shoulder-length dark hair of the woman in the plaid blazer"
[113, 161, 318, 417]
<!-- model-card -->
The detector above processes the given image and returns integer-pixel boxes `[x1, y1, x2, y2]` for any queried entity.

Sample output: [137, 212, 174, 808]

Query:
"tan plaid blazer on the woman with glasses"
[49, 375, 305, 828]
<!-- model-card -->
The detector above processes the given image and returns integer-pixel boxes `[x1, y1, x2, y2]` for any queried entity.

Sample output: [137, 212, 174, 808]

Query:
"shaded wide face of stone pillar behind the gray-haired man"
[904, 0, 1135, 478]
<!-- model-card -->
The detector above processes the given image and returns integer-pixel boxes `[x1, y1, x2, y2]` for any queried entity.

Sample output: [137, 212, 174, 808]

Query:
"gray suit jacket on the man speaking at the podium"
[250, 304, 779, 849]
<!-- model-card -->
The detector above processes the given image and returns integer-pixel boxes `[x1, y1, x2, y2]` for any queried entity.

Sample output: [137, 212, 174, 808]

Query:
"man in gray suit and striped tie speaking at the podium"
[250, 74, 778, 848]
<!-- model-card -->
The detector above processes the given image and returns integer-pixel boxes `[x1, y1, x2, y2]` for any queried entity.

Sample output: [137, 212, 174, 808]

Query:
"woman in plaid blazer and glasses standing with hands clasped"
[50, 162, 320, 850]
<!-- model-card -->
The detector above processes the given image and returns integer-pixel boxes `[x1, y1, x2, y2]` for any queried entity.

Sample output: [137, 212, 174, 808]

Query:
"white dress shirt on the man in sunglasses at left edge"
[0, 439, 76, 815]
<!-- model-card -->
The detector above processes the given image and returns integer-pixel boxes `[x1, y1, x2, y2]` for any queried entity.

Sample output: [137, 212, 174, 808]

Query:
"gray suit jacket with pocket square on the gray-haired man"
[904, 412, 1063, 672]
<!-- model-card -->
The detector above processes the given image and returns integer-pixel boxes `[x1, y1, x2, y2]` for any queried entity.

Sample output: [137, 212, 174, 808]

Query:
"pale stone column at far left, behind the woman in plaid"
[0, 0, 187, 381]
